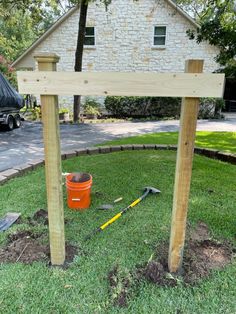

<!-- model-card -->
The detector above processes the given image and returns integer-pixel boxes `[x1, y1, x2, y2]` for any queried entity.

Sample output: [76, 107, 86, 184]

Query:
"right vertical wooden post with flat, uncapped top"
[168, 60, 203, 273]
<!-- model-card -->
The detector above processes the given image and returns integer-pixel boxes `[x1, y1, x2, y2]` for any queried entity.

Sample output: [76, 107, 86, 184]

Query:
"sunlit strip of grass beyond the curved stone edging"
[103, 131, 236, 153]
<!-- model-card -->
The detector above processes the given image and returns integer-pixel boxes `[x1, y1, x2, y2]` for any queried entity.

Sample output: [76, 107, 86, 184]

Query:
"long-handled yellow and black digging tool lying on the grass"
[85, 186, 161, 240]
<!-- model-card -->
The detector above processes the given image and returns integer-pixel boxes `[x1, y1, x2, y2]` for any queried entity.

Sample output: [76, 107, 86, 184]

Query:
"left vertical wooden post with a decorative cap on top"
[34, 54, 65, 265]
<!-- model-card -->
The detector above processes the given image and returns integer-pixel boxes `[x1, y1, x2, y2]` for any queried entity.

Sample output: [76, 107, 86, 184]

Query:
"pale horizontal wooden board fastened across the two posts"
[17, 72, 224, 98]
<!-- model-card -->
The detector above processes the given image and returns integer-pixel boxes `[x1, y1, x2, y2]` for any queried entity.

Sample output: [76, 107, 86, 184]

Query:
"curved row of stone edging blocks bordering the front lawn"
[0, 144, 236, 185]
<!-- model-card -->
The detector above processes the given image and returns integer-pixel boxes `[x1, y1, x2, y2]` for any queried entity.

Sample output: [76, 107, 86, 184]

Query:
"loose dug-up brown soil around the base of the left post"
[0, 230, 78, 264]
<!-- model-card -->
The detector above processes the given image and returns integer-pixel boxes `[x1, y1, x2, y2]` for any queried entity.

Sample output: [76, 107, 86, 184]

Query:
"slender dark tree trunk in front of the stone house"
[73, 0, 88, 122]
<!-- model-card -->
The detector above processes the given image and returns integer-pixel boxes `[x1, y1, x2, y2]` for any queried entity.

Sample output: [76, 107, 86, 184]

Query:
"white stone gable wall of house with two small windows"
[13, 0, 218, 109]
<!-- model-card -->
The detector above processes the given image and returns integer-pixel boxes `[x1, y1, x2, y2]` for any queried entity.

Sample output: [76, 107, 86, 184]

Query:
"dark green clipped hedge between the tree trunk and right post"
[105, 96, 181, 118]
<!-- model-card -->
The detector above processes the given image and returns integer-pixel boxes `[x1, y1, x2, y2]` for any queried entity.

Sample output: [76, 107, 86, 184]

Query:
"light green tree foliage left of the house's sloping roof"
[0, 0, 61, 61]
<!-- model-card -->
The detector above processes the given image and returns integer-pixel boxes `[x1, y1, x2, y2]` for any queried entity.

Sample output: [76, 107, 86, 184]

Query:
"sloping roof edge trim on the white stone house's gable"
[12, 0, 199, 67]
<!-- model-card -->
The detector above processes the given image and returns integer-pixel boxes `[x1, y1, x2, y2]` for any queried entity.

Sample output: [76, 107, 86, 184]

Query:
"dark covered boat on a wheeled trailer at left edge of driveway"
[0, 73, 24, 130]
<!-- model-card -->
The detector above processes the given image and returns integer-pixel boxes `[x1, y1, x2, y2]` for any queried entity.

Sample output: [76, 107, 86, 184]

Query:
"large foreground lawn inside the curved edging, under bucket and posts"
[0, 148, 236, 314]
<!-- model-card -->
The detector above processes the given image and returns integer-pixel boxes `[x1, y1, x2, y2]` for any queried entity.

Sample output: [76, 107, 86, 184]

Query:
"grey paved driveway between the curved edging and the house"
[0, 115, 236, 172]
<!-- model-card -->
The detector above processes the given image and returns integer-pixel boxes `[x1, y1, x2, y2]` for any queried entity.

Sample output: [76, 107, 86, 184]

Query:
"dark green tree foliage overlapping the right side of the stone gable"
[178, 0, 236, 76]
